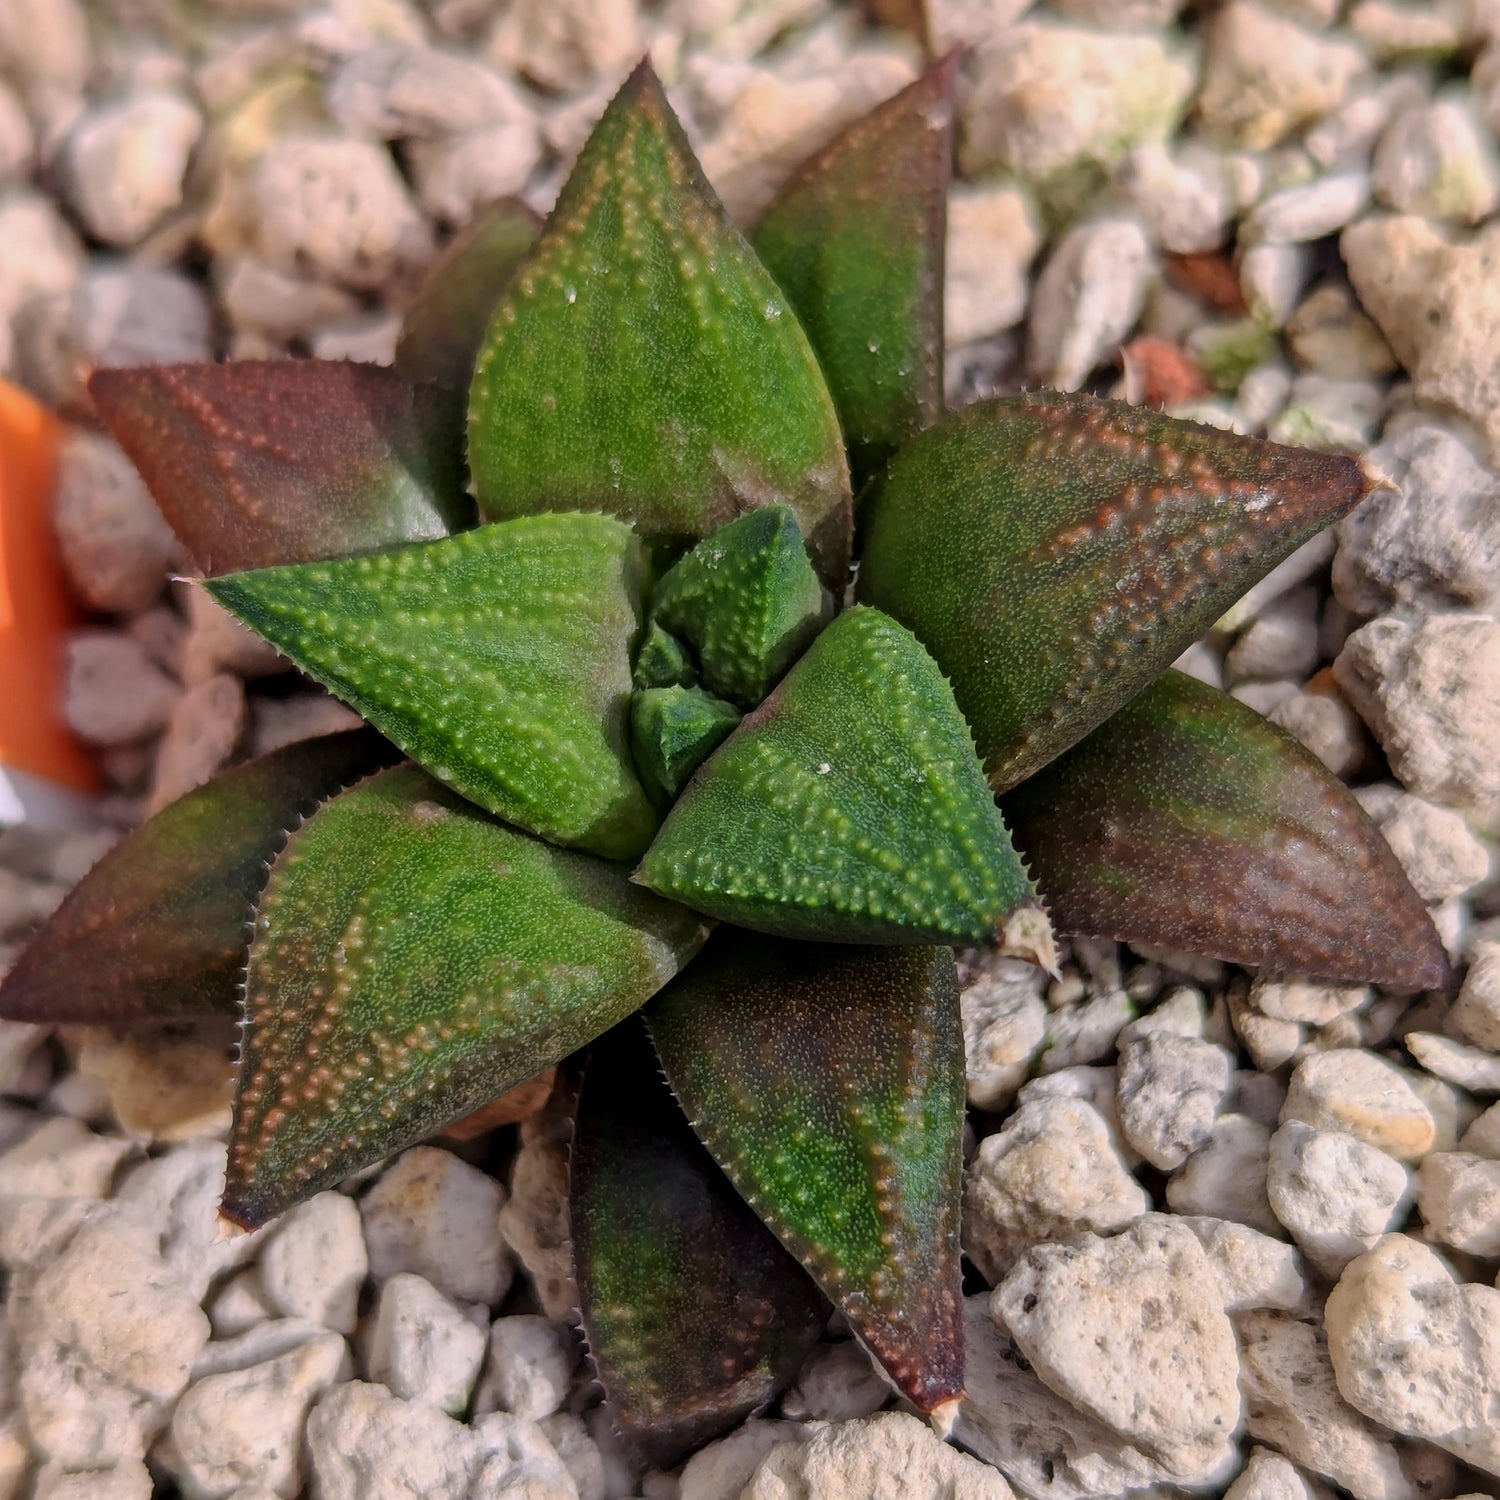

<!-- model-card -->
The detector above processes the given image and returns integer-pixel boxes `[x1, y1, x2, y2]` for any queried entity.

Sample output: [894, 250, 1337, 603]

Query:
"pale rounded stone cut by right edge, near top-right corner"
[1374, 99, 1500, 224]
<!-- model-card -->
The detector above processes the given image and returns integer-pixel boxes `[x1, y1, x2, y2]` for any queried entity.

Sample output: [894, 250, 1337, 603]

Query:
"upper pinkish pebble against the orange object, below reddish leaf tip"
[53, 428, 176, 614]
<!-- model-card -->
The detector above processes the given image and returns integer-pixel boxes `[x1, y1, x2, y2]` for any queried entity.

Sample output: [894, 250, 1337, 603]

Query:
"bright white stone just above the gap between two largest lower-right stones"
[1266, 1119, 1412, 1280]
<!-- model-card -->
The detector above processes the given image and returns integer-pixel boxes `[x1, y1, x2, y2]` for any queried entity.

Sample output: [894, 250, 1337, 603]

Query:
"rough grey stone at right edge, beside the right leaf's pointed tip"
[1334, 417, 1500, 615]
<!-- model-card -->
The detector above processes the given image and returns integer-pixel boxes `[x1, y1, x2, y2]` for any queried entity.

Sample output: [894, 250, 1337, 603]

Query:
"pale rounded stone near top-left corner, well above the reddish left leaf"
[63, 92, 203, 245]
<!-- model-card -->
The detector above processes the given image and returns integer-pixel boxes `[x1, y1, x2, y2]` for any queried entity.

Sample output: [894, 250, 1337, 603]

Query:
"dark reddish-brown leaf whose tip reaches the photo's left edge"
[0, 729, 396, 1025]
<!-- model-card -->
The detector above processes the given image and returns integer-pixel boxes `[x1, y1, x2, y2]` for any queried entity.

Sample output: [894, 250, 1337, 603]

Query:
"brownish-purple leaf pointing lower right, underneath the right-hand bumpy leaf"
[1004, 672, 1448, 990]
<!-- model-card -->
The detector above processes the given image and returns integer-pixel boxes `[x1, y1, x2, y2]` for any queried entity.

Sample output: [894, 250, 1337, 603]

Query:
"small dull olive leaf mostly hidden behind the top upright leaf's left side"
[396, 198, 542, 396]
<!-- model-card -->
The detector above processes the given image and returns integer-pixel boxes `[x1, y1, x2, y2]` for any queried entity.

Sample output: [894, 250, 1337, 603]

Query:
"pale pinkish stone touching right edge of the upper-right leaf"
[944, 183, 1043, 348]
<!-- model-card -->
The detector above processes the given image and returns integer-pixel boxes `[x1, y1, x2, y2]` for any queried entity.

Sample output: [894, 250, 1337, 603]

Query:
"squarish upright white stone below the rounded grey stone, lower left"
[368, 1271, 483, 1416]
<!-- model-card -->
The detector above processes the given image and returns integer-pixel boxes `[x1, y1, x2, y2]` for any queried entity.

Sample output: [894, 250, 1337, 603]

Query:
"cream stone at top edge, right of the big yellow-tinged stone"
[1199, 0, 1370, 152]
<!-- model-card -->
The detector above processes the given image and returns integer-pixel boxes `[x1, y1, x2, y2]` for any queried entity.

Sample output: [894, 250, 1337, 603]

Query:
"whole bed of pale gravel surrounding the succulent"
[0, 0, 1500, 1500]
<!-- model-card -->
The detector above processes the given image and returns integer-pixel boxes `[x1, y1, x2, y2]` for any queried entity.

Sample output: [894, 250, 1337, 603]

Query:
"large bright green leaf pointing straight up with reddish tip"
[470, 63, 851, 587]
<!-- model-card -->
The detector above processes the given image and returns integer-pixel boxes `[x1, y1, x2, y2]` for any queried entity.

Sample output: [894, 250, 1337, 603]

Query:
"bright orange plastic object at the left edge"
[0, 381, 99, 792]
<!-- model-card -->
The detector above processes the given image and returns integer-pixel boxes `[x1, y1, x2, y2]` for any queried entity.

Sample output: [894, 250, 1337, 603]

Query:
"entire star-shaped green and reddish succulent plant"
[0, 63, 1446, 1463]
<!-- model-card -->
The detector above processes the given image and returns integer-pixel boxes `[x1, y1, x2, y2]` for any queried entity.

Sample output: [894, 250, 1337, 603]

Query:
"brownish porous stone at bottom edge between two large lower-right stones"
[1235, 1313, 1421, 1500]
